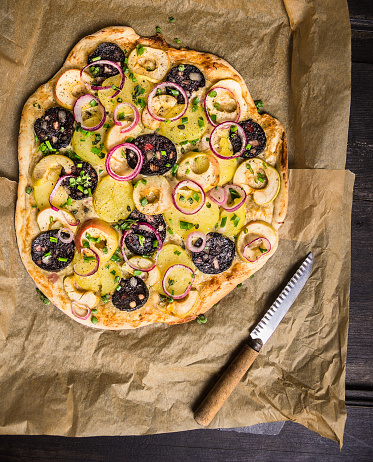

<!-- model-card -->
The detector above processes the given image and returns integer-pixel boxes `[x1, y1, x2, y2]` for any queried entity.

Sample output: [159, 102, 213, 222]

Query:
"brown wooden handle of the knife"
[194, 343, 261, 427]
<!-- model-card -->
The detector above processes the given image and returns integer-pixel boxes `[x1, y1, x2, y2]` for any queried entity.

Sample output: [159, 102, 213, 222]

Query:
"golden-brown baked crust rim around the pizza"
[15, 26, 288, 329]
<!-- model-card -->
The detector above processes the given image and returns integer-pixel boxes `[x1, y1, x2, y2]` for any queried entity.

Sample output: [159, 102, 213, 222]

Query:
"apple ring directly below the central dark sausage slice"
[133, 176, 172, 215]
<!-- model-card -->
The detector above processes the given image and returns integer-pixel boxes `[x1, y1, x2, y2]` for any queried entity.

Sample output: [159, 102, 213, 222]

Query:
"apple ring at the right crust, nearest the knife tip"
[236, 221, 278, 263]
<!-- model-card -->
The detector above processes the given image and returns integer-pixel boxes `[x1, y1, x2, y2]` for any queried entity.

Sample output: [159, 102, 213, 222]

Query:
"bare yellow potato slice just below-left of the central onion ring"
[93, 175, 135, 223]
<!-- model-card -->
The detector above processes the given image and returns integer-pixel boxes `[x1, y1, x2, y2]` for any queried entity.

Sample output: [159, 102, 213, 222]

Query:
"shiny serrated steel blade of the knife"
[250, 252, 313, 345]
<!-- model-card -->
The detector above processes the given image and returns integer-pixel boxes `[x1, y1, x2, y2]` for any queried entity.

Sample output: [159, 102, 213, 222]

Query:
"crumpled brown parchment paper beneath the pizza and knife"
[0, 0, 353, 443]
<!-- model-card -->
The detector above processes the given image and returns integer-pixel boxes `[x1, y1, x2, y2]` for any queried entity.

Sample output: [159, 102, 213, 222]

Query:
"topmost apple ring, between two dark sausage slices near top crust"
[128, 45, 170, 82]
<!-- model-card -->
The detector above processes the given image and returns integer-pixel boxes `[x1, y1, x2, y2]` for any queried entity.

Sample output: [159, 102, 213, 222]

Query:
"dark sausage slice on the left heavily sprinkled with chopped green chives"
[61, 160, 98, 200]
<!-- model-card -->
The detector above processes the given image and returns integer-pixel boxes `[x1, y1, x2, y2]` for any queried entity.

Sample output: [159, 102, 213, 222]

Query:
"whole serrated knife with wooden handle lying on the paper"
[194, 252, 313, 427]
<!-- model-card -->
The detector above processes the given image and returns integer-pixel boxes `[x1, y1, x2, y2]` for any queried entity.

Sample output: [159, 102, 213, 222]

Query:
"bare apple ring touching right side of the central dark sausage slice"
[176, 151, 220, 191]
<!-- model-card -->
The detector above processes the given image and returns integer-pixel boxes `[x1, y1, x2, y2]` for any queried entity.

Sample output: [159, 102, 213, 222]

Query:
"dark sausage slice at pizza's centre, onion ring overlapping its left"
[127, 134, 177, 176]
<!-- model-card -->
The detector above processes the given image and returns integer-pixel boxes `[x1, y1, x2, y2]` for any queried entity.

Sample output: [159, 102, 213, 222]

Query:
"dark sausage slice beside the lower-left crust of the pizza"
[31, 229, 75, 271]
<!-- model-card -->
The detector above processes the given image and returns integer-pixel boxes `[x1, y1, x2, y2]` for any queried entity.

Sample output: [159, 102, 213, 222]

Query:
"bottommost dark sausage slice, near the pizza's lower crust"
[112, 276, 149, 311]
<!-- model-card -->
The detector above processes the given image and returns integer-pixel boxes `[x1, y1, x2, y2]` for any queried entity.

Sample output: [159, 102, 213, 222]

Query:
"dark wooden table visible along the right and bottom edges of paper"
[0, 0, 373, 462]
